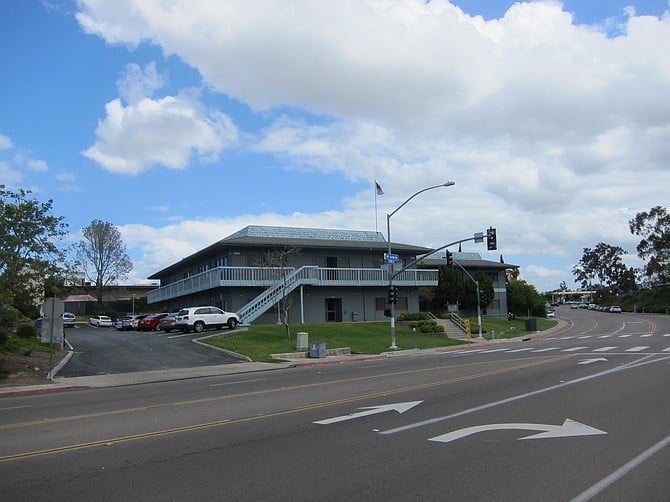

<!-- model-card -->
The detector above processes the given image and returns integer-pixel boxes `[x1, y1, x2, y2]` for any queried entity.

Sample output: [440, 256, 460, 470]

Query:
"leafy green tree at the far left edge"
[0, 185, 67, 315]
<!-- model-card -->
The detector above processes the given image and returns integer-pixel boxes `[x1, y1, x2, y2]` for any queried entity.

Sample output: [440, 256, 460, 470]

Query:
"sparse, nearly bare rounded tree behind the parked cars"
[76, 220, 133, 303]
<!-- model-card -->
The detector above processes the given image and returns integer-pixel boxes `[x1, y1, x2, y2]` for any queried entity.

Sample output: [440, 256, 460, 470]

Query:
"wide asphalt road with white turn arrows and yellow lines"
[0, 308, 670, 502]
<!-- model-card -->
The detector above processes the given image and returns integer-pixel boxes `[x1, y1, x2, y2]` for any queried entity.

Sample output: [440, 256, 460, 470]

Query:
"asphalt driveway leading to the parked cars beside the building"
[58, 323, 240, 377]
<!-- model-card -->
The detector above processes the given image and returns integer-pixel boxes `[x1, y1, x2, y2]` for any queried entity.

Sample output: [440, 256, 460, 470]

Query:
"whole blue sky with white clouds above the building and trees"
[0, 0, 670, 291]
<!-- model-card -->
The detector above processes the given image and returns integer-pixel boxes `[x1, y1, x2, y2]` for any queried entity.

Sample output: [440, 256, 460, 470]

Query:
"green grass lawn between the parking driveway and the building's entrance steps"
[204, 322, 466, 362]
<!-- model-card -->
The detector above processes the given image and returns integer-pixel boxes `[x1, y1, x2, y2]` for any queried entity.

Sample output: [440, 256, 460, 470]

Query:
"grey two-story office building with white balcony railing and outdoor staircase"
[147, 225, 438, 324]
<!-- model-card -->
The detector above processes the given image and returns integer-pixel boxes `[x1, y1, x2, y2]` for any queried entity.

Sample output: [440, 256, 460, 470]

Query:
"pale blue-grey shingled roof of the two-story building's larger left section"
[149, 225, 431, 279]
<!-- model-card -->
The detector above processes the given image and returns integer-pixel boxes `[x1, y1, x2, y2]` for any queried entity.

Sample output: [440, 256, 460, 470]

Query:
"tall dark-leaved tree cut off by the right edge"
[628, 206, 670, 284]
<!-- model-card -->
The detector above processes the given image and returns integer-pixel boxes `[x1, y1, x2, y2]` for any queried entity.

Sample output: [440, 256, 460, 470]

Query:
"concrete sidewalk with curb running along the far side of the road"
[0, 320, 567, 398]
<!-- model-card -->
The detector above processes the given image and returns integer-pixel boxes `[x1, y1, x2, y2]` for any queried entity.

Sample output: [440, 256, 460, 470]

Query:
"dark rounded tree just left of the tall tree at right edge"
[572, 242, 636, 292]
